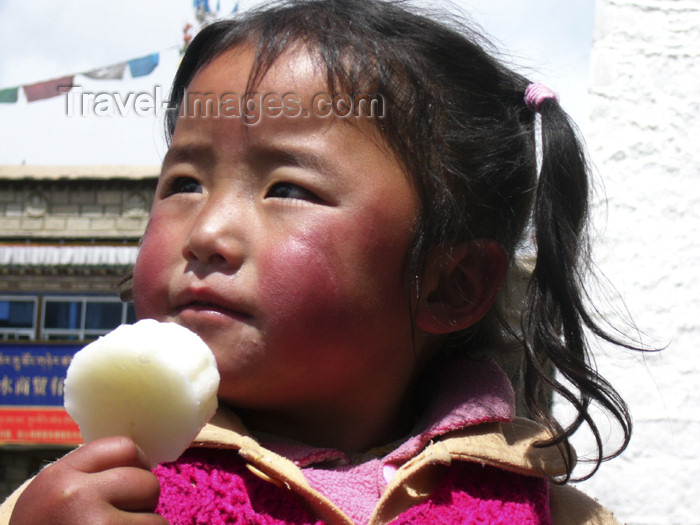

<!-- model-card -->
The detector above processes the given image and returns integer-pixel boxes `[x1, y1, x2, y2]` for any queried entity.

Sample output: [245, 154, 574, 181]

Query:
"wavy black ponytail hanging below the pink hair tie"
[522, 97, 632, 482]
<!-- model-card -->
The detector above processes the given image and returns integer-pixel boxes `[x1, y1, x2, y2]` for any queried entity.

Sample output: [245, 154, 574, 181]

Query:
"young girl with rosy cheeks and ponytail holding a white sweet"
[1, 0, 630, 525]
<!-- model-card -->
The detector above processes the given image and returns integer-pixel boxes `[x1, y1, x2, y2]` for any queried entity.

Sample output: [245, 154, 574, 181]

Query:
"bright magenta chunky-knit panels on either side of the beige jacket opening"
[156, 449, 552, 525]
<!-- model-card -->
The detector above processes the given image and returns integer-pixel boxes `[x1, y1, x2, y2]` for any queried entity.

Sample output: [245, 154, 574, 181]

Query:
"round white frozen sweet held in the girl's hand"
[64, 319, 219, 465]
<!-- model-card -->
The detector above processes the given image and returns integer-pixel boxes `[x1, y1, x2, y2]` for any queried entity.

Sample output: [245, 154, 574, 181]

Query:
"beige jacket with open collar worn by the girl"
[0, 409, 619, 525]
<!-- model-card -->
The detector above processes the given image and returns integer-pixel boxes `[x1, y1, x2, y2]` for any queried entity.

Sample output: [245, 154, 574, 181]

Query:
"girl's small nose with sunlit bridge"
[184, 198, 245, 271]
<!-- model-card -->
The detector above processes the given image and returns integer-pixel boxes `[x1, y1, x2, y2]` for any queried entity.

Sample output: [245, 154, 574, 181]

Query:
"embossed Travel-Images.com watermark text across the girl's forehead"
[64, 86, 385, 125]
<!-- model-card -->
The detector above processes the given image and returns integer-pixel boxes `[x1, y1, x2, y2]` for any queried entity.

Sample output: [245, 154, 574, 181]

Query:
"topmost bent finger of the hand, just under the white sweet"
[65, 436, 150, 474]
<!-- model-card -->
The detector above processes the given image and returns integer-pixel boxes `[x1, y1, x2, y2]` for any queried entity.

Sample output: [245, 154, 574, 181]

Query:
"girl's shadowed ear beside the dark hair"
[415, 239, 508, 335]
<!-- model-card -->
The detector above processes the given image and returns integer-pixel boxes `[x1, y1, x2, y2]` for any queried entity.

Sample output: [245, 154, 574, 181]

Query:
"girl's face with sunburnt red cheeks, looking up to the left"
[134, 45, 418, 448]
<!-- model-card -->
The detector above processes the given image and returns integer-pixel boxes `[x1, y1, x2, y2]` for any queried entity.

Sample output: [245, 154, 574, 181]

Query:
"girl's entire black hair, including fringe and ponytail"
[166, 0, 631, 479]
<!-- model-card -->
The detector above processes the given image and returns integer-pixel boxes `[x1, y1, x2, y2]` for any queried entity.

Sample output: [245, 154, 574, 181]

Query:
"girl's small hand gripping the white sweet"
[10, 437, 168, 525]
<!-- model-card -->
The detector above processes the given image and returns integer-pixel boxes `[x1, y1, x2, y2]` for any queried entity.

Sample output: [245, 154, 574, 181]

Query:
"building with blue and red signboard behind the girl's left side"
[0, 166, 159, 498]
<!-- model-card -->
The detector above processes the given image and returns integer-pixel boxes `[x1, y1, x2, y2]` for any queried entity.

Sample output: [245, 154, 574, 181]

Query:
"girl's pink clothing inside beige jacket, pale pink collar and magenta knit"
[154, 361, 551, 525]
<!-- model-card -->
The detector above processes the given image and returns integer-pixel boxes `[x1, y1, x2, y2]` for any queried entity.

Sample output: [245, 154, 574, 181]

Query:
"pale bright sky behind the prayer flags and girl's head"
[0, 0, 595, 165]
